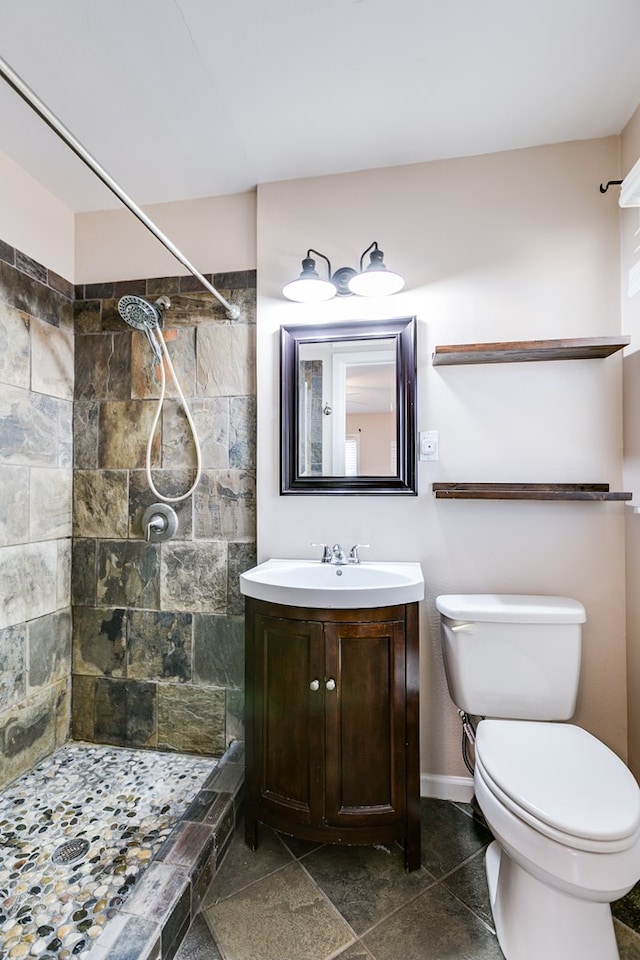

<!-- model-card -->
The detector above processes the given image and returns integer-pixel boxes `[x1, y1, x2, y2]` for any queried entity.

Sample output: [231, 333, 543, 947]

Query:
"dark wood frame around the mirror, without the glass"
[280, 317, 418, 496]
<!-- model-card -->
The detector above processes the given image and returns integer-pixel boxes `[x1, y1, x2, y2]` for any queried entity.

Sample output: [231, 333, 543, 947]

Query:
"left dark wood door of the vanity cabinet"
[252, 616, 324, 823]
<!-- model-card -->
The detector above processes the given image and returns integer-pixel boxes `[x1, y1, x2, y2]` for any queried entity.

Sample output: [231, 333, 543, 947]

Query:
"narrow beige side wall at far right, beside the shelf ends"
[620, 108, 640, 777]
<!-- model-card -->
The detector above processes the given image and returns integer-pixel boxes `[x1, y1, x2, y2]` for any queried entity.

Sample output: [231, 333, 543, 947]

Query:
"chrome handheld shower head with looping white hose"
[118, 296, 202, 503]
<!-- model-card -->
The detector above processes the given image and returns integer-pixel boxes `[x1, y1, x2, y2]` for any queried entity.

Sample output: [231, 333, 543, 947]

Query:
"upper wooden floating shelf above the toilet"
[432, 337, 631, 367]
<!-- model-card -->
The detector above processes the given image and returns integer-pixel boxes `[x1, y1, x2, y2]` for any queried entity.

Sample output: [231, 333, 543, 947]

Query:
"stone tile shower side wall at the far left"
[0, 241, 74, 788]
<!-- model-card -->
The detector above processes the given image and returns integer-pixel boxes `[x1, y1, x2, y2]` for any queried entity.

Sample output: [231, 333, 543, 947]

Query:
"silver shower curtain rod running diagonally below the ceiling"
[0, 57, 240, 320]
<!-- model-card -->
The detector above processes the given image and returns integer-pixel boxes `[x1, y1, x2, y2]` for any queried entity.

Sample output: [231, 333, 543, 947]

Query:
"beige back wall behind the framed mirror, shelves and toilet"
[257, 138, 626, 789]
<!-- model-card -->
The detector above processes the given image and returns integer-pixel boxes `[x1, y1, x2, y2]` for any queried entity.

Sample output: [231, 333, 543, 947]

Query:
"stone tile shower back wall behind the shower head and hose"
[72, 271, 255, 756]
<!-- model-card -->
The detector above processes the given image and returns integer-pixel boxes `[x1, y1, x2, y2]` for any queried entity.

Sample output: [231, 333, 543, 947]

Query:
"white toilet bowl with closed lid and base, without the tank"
[474, 720, 640, 960]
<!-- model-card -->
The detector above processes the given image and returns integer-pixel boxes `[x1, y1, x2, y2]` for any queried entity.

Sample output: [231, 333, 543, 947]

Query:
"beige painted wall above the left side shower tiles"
[0, 153, 74, 283]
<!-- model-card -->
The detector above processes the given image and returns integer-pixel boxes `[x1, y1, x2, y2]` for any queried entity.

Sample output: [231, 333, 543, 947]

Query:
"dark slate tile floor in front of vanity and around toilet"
[176, 800, 640, 960]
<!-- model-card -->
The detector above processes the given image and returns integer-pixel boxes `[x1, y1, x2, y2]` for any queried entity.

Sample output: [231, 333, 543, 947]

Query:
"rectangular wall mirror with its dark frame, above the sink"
[280, 317, 417, 494]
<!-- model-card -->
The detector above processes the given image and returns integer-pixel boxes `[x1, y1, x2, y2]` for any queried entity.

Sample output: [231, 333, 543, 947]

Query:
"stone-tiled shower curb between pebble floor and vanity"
[89, 740, 244, 960]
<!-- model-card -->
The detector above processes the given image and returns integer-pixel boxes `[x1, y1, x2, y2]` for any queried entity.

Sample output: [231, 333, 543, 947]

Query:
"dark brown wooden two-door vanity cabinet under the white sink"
[245, 597, 420, 870]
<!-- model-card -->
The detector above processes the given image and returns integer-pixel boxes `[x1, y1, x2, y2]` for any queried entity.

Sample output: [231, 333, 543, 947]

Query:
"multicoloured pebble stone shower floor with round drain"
[0, 743, 217, 960]
